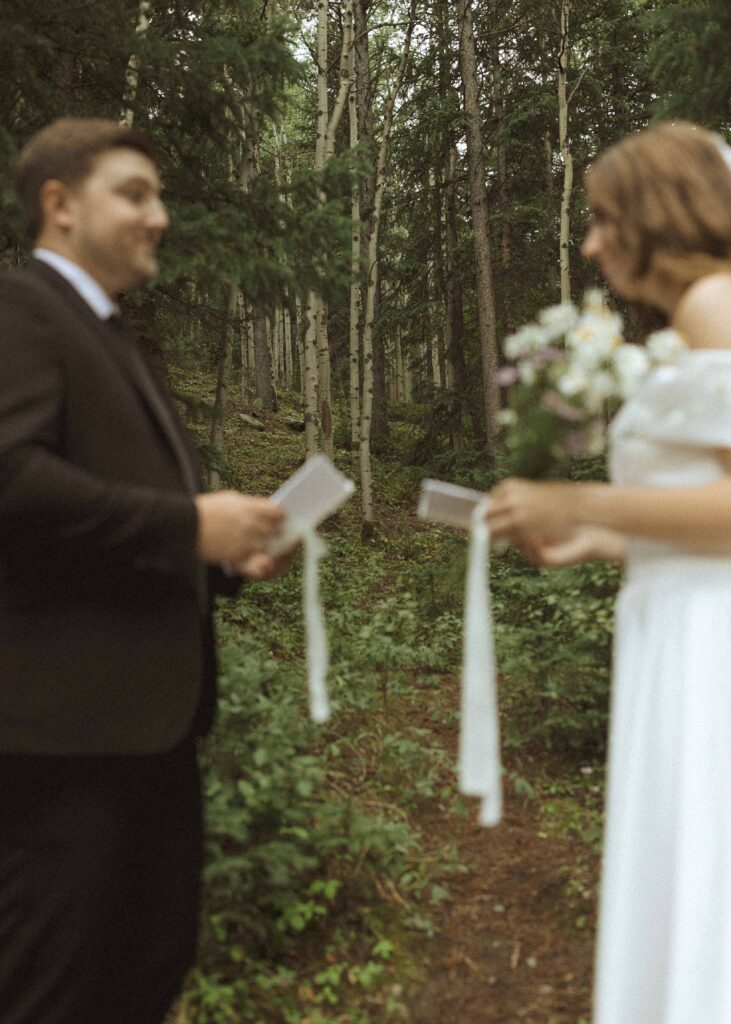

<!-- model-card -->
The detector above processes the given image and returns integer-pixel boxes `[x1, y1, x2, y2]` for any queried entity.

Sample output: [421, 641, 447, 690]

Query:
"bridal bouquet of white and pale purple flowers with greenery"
[498, 290, 685, 477]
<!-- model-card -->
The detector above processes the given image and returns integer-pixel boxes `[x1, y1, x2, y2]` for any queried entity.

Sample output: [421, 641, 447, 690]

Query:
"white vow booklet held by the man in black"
[269, 455, 355, 556]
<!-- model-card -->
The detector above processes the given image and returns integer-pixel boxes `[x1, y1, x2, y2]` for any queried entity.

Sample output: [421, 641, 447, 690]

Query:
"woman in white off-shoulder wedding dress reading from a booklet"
[488, 124, 731, 1024]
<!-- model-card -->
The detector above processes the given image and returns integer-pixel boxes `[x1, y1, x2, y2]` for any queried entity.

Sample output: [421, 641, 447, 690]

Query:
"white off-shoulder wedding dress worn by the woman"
[594, 349, 731, 1024]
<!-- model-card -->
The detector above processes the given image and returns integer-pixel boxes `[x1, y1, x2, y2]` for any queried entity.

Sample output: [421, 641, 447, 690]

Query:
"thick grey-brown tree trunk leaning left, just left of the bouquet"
[458, 0, 500, 452]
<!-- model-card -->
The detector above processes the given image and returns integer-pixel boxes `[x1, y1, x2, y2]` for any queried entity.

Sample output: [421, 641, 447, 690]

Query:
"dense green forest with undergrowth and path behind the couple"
[0, 0, 731, 1024]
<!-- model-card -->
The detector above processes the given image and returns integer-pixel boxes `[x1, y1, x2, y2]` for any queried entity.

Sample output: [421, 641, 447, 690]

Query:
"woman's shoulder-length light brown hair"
[586, 122, 731, 288]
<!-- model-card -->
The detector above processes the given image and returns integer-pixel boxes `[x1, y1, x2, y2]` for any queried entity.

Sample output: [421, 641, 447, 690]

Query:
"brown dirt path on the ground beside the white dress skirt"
[406, 720, 595, 1024]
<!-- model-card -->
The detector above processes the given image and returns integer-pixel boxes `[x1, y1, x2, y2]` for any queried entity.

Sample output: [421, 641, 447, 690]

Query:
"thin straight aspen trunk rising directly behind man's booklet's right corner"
[348, 39, 360, 480]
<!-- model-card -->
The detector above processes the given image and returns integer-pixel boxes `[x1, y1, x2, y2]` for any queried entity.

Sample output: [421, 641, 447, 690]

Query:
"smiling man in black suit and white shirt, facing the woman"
[0, 119, 284, 1024]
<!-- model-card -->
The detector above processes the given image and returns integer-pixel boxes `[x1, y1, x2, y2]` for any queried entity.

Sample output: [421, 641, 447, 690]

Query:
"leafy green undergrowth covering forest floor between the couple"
[173, 374, 615, 1024]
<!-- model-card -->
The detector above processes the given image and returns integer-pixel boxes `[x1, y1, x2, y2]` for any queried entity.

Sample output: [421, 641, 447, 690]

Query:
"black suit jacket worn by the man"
[0, 261, 225, 753]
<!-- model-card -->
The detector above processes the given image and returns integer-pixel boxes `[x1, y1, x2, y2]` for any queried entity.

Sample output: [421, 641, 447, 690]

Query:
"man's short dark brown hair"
[15, 118, 155, 238]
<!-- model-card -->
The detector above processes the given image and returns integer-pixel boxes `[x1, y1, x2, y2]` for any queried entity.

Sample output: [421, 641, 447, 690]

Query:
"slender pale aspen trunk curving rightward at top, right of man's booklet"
[360, 6, 416, 537]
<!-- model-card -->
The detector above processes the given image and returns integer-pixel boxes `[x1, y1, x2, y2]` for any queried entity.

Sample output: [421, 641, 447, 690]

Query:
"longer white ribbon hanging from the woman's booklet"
[460, 498, 503, 825]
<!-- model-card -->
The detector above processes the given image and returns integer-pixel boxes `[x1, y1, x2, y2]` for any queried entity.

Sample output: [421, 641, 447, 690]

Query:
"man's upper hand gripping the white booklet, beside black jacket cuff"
[196, 490, 285, 570]
